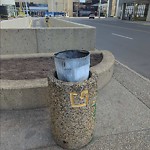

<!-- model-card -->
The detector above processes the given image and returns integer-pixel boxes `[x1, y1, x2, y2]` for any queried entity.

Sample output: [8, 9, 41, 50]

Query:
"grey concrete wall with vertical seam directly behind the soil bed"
[0, 20, 96, 55]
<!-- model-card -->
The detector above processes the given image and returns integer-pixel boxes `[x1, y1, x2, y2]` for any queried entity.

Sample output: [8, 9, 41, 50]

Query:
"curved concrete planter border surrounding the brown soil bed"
[0, 51, 114, 110]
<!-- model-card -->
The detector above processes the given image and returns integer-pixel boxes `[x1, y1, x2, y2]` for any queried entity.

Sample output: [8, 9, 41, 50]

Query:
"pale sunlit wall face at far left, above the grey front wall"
[0, 17, 32, 29]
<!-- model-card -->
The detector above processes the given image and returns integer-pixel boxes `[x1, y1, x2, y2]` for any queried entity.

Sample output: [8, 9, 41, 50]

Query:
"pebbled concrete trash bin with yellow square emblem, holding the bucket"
[48, 73, 98, 149]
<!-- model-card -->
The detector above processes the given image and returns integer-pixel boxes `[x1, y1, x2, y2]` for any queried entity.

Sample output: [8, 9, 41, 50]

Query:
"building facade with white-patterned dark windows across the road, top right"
[86, 0, 150, 21]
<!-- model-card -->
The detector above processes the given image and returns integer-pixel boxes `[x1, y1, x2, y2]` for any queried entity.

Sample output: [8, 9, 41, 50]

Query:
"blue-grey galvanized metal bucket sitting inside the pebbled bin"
[54, 50, 90, 82]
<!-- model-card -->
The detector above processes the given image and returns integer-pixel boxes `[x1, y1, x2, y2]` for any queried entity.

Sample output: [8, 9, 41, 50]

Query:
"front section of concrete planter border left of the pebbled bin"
[0, 78, 48, 110]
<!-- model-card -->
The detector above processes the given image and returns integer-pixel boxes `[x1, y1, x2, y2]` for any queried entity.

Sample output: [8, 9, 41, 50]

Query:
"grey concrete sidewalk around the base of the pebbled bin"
[0, 62, 150, 150]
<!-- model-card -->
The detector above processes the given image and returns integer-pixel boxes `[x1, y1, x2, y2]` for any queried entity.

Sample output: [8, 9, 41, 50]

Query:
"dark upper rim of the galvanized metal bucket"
[54, 50, 90, 59]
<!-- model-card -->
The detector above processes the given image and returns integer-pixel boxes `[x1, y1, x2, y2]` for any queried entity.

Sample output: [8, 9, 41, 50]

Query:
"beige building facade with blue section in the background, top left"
[15, 0, 73, 16]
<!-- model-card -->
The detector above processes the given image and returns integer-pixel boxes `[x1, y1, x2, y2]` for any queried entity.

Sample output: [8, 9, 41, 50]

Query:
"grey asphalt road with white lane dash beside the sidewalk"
[63, 18, 150, 79]
